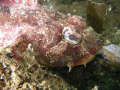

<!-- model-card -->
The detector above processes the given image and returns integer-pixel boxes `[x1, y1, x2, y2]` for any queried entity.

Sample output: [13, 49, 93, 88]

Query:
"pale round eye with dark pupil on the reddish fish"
[63, 27, 81, 44]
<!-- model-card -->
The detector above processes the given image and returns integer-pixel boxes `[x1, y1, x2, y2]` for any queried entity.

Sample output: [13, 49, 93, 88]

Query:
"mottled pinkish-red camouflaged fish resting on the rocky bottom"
[0, 0, 102, 67]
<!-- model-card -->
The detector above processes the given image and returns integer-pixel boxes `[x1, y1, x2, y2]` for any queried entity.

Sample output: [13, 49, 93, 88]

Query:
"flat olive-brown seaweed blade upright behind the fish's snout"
[86, 1, 106, 33]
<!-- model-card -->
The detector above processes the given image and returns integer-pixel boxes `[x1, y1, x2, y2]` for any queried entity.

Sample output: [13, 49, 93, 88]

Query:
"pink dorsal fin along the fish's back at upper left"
[0, 0, 38, 7]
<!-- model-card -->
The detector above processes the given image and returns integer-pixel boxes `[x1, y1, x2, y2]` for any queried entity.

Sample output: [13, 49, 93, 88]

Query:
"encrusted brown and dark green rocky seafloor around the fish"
[0, 0, 120, 90]
